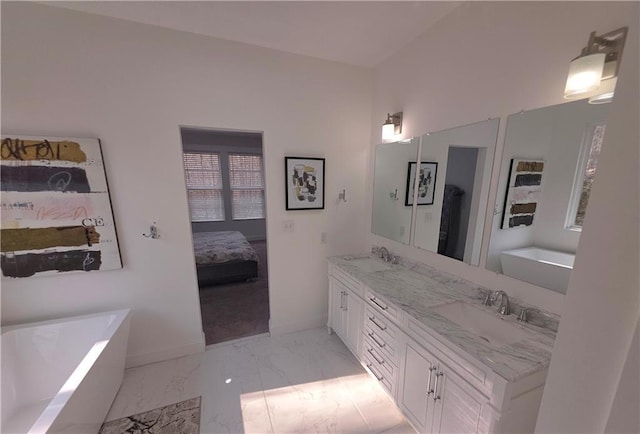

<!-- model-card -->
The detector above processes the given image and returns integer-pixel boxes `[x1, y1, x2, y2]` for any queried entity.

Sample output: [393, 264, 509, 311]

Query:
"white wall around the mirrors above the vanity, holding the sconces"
[369, 2, 634, 313]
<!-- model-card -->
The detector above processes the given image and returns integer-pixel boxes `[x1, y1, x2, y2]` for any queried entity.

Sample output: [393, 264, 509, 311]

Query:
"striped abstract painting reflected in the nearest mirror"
[500, 158, 544, 229]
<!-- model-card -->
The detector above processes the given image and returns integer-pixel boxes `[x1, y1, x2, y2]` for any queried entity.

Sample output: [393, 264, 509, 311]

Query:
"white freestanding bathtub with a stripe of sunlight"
[1, 309, 129, 434]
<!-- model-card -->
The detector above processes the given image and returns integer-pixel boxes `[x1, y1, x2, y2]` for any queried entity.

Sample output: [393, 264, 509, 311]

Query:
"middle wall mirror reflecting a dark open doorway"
[413, 119, 499, 265]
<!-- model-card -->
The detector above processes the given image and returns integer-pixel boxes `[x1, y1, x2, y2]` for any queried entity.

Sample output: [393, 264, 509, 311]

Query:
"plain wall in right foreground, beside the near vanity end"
[536, 6, 640, 433]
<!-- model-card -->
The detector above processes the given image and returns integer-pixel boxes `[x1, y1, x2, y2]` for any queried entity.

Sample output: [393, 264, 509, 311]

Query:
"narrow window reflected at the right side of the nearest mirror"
[566, 124, 605, 230]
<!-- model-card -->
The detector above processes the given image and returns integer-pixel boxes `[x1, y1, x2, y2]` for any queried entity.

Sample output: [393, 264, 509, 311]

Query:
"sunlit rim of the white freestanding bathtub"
[1, 308, 131, 434]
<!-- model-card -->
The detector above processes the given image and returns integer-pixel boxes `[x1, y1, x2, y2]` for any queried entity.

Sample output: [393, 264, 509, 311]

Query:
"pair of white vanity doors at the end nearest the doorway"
[327, 267, 364, 359]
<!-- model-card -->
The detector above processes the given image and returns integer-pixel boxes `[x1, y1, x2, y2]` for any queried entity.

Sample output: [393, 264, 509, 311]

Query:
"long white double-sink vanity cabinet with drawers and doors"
[328, 262, 552, 434]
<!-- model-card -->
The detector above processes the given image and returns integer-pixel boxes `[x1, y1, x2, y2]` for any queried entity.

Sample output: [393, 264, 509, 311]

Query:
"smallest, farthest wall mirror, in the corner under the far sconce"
[371, 137, 420, 244]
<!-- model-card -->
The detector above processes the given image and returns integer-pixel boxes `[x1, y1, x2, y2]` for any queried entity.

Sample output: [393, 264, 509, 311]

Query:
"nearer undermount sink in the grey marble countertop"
[432, 301, 531, 345]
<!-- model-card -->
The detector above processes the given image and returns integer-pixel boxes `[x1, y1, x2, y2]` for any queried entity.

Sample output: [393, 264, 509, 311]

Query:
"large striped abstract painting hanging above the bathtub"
[0, 134, 122, 279]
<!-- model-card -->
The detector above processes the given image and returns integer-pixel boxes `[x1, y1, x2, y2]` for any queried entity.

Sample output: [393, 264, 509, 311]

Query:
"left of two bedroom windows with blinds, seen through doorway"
[183, 152, 224, 222]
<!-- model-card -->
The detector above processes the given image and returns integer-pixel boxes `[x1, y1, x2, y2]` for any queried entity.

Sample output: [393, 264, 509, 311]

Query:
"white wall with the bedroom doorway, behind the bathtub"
[2, 2, 372, 365]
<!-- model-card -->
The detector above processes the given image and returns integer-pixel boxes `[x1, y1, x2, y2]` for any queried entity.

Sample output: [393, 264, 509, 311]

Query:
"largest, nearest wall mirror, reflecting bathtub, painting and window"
[487, 100, 609, 294]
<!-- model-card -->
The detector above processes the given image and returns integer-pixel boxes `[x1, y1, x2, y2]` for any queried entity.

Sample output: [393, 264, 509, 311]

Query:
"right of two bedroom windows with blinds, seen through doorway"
[229, 154, 264, 220]
